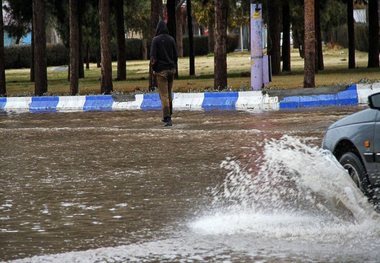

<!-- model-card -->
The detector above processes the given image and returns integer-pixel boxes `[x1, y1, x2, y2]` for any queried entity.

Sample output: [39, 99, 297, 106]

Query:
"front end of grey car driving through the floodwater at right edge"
[323, 93, 380, 200]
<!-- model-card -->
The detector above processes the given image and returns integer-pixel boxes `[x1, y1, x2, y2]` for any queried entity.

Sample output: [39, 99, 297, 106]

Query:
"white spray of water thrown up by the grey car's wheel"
[191, 135, 380, 239]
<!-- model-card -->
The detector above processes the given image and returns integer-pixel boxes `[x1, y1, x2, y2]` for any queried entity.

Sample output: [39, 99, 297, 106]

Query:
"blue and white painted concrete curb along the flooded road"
[0, 83, 380, 113]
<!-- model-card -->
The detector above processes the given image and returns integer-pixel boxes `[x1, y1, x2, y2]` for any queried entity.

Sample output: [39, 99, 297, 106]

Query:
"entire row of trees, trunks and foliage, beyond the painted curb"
[0, 0, 379, 96]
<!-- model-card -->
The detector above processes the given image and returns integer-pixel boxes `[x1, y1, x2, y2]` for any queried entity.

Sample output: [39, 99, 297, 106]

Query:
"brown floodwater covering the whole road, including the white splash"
[0, 107, 380, 262]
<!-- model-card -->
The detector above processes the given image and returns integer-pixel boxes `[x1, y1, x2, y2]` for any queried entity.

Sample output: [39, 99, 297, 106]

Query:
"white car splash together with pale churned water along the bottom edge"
[7, 136, 380, 262]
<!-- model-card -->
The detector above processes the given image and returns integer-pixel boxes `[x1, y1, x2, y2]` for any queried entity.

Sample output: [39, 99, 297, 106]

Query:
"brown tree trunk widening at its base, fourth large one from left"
[99, 0, 113, 94]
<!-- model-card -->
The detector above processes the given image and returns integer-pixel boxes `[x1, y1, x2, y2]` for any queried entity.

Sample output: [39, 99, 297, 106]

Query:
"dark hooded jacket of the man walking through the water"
[150, 20, 178, 72]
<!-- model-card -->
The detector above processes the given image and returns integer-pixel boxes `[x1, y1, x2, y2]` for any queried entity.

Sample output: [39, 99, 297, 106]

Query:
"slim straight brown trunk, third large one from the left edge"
[69, 0, 79, 95]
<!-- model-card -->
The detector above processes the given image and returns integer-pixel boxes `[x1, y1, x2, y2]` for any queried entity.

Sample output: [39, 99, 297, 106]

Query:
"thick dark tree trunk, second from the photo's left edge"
[33, 0, 47, 96]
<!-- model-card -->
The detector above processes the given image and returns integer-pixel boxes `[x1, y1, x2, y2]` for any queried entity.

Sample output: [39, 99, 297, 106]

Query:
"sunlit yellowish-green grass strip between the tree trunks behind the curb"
[6, 49, 380, 96]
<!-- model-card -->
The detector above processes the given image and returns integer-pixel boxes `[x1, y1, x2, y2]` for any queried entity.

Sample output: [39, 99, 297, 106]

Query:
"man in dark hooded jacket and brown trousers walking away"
[150, 20, 178, 126]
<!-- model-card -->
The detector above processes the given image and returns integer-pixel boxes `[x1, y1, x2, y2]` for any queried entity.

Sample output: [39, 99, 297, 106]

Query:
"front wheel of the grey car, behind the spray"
[339, 152, 366, 191]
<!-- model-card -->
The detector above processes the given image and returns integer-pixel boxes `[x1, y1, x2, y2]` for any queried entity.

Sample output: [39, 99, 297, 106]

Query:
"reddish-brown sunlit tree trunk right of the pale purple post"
[303, 0, 315, 88]
